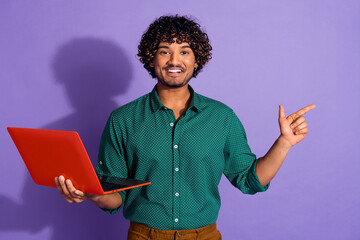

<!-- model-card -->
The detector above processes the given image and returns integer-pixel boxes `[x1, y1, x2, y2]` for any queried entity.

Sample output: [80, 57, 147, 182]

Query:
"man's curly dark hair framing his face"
[138, 15, 212, 78]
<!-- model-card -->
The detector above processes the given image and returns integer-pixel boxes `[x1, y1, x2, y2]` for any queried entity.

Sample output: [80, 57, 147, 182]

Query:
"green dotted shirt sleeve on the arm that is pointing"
[224, 112, 270, 194]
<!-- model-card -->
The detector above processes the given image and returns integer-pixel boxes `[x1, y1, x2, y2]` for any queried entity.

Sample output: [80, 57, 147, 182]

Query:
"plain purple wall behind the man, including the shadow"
[0, 0, 360, 240]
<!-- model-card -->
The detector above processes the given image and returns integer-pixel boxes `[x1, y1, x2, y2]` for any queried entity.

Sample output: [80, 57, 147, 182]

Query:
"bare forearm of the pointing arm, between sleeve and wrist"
[256, 136, 291, 186]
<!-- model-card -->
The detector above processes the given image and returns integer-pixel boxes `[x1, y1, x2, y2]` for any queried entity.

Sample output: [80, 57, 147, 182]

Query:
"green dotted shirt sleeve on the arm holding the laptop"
[96, 113, 128, 214]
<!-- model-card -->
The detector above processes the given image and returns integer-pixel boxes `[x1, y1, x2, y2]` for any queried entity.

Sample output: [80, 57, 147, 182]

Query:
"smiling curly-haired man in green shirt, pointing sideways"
[56, 16, 315, 239]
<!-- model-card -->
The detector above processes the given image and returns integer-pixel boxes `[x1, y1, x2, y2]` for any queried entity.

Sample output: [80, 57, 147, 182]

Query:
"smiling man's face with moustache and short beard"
[150, 39, 198, 88]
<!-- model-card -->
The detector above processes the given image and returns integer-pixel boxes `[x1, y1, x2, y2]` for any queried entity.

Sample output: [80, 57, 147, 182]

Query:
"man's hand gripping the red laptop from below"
[55, 176, 100, 203]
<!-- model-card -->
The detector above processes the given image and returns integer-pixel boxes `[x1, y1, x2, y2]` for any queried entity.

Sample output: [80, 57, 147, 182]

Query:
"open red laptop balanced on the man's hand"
[7, 127, 151, 195]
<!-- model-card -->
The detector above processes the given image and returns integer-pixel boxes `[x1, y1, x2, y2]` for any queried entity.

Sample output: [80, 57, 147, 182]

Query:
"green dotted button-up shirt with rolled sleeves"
[96, 86, 268, 230]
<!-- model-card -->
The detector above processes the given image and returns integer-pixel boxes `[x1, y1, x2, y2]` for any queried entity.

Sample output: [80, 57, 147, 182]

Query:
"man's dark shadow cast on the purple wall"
[0, 38, 132, 240]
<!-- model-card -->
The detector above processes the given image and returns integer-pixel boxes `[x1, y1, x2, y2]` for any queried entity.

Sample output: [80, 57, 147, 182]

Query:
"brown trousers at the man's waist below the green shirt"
[127, 222, 221, 240]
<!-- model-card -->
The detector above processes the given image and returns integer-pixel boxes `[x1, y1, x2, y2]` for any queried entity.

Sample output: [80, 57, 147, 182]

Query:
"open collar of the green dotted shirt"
[150, 85, 202, 112]
